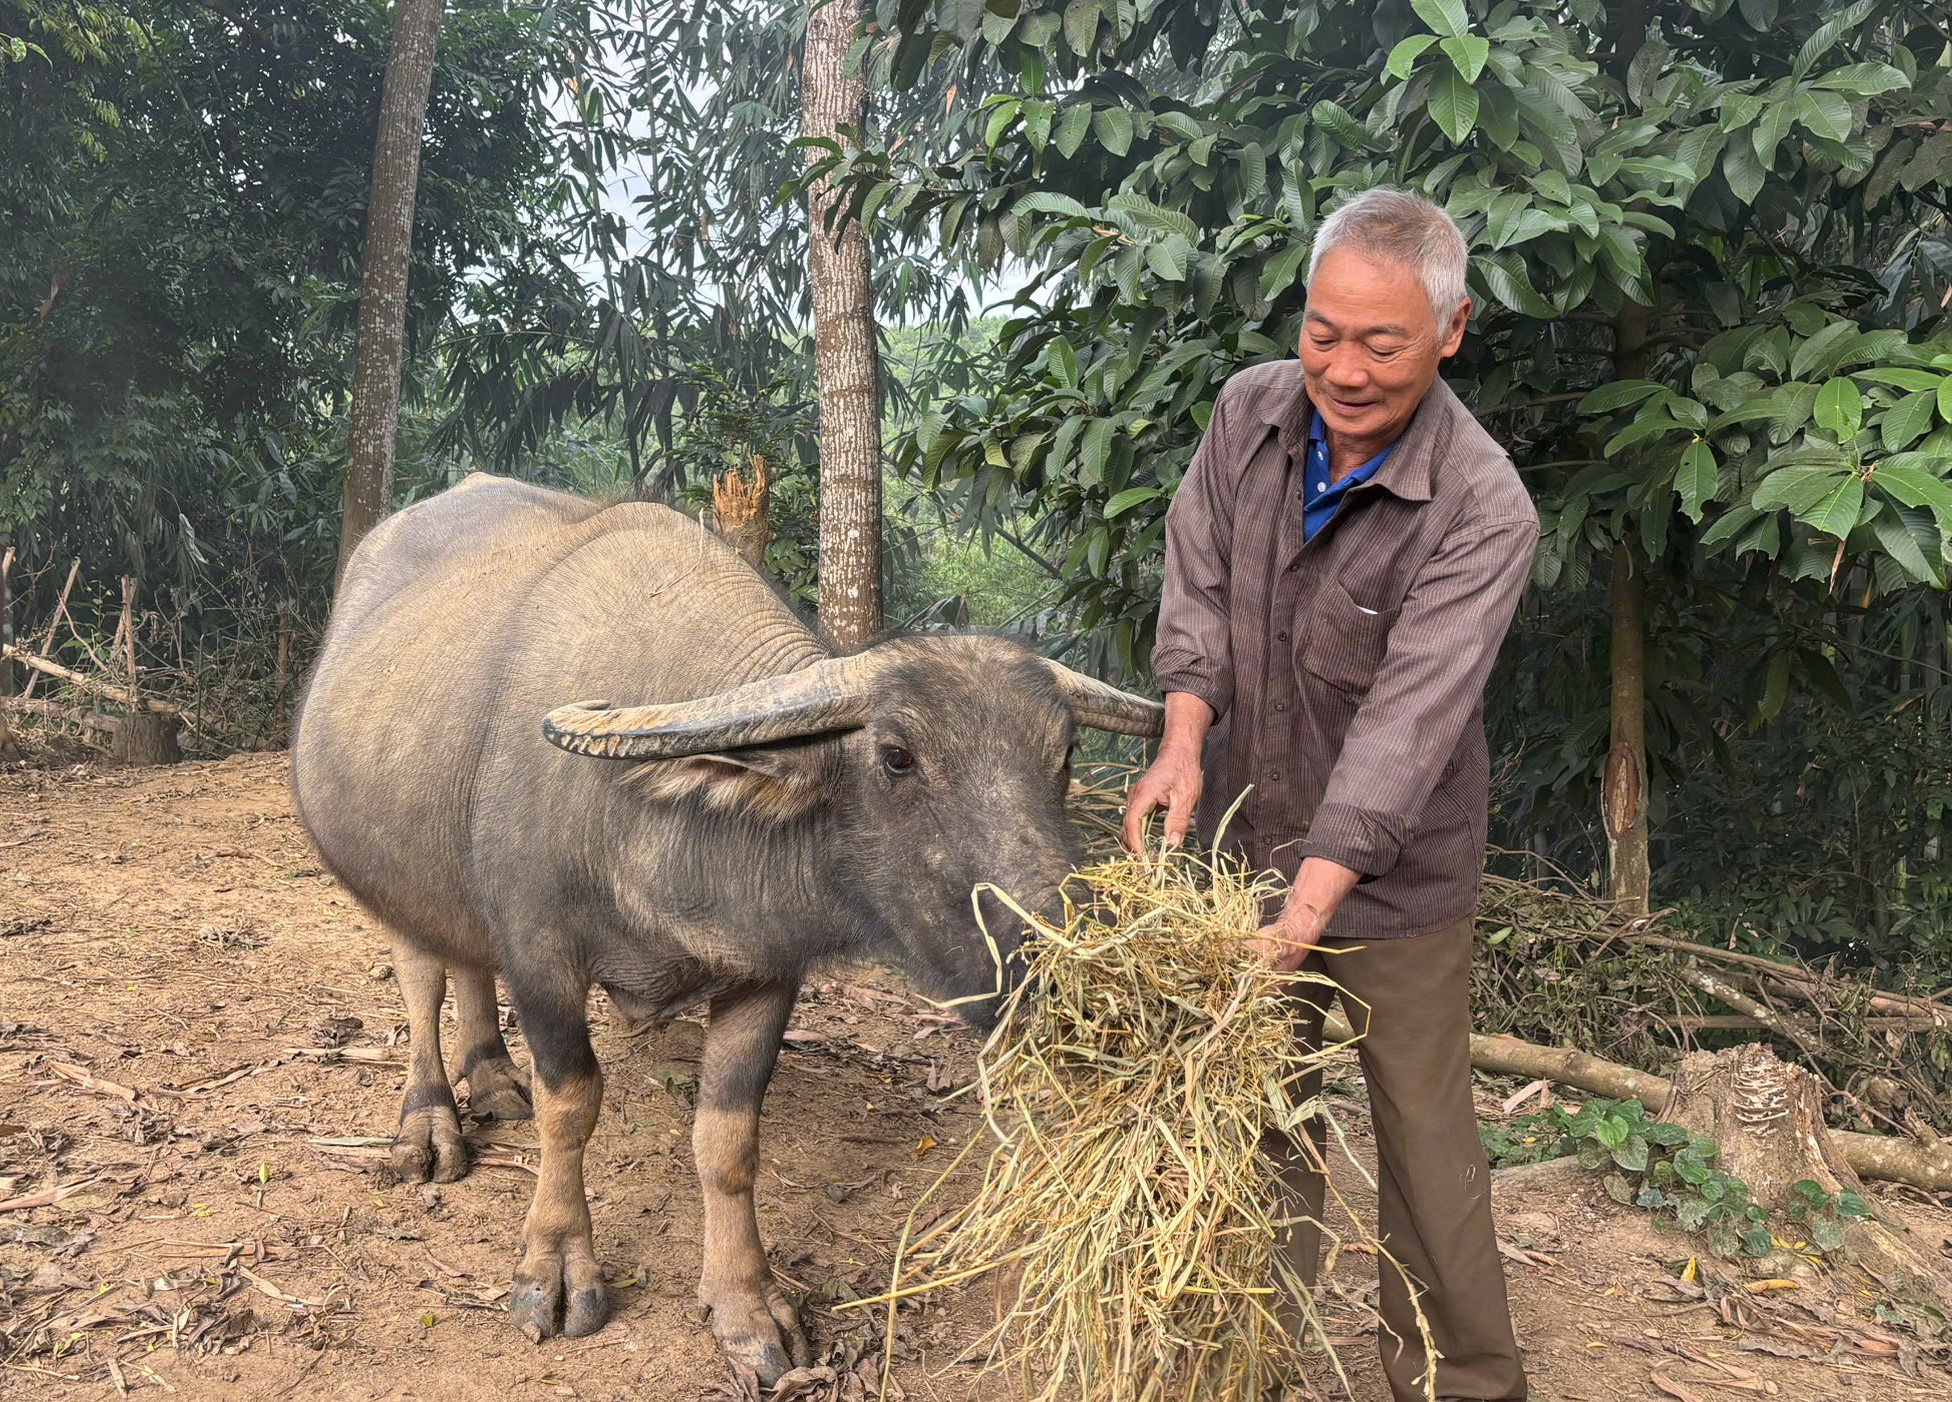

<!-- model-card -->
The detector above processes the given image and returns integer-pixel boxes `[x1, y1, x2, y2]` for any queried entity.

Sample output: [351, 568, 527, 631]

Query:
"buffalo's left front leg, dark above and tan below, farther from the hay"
[508, 988, 609, 1343]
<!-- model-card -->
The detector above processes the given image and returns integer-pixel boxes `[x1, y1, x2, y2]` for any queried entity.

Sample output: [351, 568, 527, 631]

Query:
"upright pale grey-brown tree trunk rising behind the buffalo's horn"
[800, 0, 880, 648]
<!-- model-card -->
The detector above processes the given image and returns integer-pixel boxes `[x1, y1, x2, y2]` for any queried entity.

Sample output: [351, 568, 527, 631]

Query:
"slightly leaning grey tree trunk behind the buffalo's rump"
[340, 0, 443, 574]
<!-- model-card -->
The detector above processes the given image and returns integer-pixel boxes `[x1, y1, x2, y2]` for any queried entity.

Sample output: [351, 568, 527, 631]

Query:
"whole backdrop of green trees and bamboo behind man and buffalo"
[0, 0, 1952, 967]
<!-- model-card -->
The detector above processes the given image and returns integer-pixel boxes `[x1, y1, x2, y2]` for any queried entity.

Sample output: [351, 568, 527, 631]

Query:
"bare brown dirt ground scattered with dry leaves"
[0, 756, 1952, 1402]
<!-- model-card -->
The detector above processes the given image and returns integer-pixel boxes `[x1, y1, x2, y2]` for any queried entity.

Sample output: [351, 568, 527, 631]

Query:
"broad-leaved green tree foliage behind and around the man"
[851, 0, 1952, 953]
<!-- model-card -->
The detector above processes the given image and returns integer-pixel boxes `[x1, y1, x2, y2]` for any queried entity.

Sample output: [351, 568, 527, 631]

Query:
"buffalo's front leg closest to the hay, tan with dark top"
[691, 986, 808, 1386]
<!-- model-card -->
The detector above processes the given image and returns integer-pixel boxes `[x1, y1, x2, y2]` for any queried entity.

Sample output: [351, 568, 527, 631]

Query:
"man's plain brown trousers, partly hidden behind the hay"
[1269, 922, 1525, 1402]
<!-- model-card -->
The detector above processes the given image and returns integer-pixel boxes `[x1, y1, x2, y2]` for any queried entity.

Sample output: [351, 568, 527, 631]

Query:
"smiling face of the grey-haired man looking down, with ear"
[1302, 248, 1470, 443]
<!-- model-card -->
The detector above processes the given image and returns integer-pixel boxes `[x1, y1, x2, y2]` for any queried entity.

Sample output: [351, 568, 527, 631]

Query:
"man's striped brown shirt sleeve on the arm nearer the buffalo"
[1152, 389, 1234, 717]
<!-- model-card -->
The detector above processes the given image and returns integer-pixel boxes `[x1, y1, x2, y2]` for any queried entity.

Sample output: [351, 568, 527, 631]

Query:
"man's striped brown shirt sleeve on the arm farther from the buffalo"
[1302, 517, 1538, 877]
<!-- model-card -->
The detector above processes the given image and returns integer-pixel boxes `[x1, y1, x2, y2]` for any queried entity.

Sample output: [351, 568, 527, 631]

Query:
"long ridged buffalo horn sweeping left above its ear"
[543, 656, 874, 760]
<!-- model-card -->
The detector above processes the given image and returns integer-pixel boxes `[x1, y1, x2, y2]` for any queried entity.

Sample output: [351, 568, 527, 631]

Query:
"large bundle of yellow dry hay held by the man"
[861, 855, 1407, 1402]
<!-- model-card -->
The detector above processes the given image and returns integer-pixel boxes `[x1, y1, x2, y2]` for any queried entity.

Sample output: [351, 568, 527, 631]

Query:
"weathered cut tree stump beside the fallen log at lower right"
[1661, 1043, 1948, 1299]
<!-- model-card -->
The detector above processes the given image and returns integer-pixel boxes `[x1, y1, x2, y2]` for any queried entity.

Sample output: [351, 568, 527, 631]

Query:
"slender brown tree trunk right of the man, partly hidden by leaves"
[1601, 0, 1653, 912]
